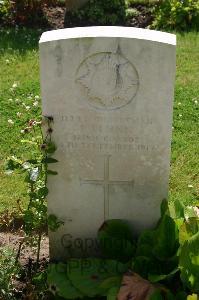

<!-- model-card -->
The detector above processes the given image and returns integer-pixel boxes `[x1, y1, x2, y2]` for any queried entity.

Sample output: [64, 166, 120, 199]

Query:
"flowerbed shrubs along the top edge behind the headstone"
[0, 0, 199, 30]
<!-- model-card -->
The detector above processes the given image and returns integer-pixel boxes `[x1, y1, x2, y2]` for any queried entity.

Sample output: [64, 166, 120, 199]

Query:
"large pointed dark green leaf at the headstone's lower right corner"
[136, 210, 179, 278]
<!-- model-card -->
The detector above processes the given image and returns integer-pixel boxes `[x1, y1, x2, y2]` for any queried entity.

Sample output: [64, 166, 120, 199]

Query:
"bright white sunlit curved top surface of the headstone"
[40, 26, 176, 45]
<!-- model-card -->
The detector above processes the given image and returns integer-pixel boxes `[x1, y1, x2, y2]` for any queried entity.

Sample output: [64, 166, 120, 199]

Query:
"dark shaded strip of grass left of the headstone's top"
[0, 27, 46, 54]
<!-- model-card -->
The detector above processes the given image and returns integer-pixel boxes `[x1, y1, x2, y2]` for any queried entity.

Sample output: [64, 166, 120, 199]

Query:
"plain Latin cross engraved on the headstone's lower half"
[80, 155, 134, 220]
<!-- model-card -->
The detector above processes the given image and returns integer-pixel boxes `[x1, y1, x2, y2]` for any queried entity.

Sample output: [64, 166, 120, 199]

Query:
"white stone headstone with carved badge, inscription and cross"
[40, 27, 176, 259]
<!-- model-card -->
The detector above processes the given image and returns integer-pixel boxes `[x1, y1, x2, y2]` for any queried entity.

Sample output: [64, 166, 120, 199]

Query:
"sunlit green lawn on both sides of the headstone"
[0, 29, 199, 212]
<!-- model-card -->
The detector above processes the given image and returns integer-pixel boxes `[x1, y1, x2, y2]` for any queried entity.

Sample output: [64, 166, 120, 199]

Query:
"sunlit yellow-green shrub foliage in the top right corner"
[152, 0, 199, 30]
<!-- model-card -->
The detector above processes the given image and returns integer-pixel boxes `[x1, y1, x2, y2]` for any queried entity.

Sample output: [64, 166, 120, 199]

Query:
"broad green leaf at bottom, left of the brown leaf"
[67, 258, 127, 297]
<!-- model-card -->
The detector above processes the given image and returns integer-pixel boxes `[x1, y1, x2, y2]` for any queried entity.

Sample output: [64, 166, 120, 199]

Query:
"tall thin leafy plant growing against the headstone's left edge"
[5, 117, 62, 264]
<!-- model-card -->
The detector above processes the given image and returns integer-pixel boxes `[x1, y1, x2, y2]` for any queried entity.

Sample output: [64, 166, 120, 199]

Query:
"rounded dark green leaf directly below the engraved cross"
[97, 219, 135, 261]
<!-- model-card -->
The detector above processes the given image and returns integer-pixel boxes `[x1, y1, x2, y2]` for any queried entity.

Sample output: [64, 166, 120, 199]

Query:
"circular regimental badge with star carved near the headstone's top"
[76, 50, 139, 110]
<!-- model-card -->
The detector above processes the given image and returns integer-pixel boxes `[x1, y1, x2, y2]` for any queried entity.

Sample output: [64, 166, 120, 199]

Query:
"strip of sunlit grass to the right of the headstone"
[170, 33, 199, 204]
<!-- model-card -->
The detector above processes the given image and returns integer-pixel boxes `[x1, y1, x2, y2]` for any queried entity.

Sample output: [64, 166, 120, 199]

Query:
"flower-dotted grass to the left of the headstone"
[0, 29, 41, 212]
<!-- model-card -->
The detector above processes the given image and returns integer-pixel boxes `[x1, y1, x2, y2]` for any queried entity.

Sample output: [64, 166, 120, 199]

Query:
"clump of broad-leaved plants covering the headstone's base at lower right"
[47, 201, 199, 300]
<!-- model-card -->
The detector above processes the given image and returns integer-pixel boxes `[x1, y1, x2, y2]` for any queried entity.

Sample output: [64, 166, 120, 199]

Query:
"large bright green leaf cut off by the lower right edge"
[179, 232, 199, 293]
